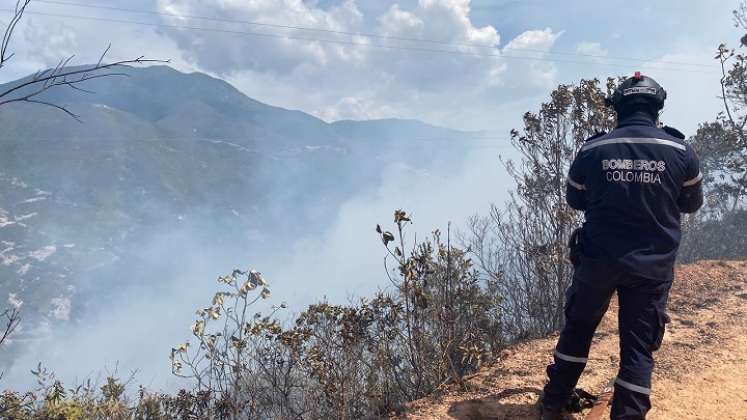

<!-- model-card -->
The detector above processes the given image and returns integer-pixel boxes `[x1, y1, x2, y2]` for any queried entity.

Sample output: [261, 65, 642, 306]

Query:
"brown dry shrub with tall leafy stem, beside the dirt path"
[377, 211, 502, 394]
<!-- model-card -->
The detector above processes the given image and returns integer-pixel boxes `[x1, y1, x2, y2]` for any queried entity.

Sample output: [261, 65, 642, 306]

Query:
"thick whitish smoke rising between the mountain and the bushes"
[4, 144, 510, 390]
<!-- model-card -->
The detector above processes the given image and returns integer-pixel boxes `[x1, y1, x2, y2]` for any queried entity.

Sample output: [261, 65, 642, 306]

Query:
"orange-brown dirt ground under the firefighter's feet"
[400, 261, 747, 420]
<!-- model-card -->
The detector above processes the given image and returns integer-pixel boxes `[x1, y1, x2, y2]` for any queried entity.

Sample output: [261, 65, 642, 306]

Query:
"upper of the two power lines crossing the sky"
[36, 0, 711, 67]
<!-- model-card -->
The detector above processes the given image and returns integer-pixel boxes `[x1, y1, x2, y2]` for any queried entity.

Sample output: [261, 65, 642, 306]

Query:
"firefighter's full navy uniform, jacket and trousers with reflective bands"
[544, 114, 703, 419]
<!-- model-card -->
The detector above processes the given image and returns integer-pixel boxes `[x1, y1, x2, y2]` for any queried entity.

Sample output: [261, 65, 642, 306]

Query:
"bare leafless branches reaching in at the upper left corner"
[0, 0, 168, 121]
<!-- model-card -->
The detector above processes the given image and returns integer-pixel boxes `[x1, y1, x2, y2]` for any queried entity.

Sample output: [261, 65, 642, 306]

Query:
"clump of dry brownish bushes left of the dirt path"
[166, 211, 503, 419]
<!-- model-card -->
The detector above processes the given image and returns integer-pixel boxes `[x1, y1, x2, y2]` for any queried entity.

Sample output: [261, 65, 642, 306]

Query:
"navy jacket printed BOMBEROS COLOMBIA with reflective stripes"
[566, 114, 703, 280]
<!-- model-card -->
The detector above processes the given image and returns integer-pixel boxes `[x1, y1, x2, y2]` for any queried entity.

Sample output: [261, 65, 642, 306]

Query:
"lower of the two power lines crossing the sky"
[0, 9, 710, 74]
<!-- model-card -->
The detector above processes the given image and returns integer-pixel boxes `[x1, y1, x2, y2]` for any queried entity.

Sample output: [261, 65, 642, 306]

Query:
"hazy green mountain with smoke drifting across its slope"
[0, 66, 480, 340]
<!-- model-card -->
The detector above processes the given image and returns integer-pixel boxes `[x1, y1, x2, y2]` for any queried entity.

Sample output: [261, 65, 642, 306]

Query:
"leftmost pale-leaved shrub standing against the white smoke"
[170, 270, 292, 419]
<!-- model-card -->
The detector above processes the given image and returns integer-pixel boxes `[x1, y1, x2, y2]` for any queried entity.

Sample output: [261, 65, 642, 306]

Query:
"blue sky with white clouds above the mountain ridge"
[0, 0, 740, 134]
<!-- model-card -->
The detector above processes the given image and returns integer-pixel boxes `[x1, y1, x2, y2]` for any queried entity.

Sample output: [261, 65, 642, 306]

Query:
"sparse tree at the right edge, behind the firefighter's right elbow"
[679, 1, 747, 261]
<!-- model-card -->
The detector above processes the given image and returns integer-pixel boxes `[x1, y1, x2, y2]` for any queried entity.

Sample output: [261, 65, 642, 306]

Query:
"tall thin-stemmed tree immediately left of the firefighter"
[468, 79, 616, 339]
